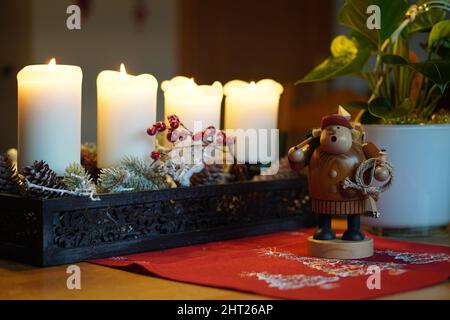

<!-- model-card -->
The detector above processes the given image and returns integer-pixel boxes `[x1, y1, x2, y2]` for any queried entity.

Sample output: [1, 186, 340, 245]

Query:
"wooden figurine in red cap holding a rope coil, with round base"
[288, 107, 393, 259]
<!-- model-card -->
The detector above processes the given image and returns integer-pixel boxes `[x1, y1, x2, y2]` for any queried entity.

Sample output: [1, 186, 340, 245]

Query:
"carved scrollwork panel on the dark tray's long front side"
[53, 189, 309, 248]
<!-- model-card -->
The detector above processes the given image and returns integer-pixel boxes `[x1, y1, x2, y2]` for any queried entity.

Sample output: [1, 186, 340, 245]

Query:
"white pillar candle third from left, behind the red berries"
[161, 76, 223, 130]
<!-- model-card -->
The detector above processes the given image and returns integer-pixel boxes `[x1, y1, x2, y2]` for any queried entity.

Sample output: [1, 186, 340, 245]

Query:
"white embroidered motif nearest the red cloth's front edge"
[241, 272, 339, 290]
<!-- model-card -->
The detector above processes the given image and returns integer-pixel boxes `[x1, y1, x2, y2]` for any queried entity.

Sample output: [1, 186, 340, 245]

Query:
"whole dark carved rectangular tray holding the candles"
[0, 176, 315, 266]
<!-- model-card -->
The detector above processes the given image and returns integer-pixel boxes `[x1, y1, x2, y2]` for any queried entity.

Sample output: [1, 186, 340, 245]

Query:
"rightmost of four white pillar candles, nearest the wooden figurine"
[224, 79, 283, 163]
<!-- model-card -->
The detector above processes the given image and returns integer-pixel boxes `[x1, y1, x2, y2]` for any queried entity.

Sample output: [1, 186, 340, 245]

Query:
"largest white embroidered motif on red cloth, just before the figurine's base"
[261, 249, 406, 278]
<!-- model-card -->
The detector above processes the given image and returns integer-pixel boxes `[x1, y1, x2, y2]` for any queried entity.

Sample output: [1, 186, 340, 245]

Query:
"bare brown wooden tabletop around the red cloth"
[0, 222, 450, 300]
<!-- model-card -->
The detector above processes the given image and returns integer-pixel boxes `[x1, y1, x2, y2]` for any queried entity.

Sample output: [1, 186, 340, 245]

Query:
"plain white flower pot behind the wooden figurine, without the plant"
[363, 125, 450, 236]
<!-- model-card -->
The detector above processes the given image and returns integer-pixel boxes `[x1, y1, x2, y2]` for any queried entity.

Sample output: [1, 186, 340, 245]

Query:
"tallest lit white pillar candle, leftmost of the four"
[17, 59, 83, 176]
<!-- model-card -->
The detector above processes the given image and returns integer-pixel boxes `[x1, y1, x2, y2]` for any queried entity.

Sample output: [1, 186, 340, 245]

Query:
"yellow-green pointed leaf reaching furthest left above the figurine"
[295, 36, 370, 84]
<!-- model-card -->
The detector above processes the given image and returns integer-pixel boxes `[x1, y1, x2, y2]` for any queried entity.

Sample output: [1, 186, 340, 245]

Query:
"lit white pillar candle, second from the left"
[97, 64, 158, 168]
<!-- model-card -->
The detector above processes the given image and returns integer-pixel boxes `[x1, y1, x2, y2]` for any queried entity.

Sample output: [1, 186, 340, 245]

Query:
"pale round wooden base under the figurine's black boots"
[308, 235, 373, 259]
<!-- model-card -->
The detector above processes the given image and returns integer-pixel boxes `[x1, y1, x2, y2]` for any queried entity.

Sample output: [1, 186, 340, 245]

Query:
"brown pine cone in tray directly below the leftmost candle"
[22, 161, 64, 199]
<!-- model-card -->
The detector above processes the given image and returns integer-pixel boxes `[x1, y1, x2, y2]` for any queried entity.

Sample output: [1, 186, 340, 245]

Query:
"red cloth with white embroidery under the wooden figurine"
[91, 229, 450, 299]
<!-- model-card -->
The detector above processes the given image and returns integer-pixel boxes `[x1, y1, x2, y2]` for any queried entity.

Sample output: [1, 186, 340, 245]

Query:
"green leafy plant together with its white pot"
[297, 0, 450, 235]
